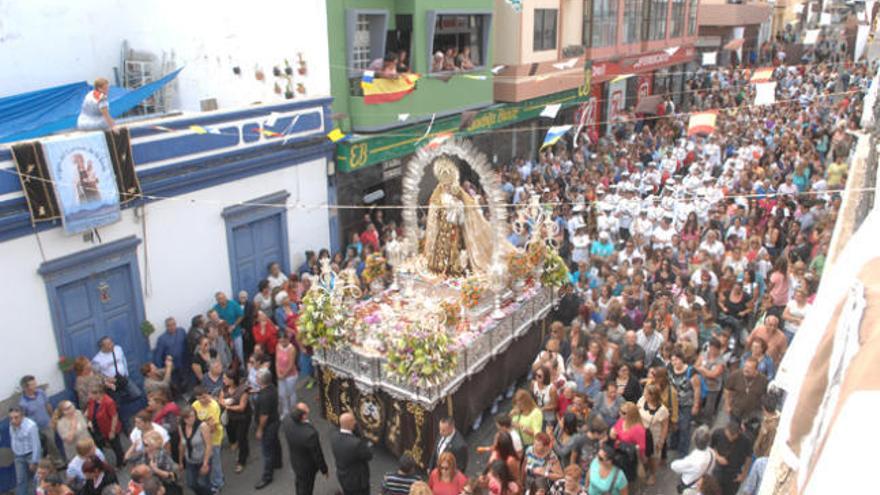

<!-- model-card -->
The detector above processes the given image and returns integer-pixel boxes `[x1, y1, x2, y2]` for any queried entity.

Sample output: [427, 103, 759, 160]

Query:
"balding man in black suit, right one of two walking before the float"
[333, 413, 373, 495]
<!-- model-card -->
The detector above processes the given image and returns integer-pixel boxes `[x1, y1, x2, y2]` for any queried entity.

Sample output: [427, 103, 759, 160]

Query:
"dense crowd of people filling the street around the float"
[10, 56, 869, 495]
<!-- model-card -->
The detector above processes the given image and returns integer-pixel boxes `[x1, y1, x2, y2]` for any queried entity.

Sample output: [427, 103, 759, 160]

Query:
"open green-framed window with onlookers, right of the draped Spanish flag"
[426, 11, 492, 73]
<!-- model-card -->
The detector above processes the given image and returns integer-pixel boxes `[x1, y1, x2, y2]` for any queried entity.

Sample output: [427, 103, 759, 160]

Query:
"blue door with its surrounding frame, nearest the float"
[223, 191, 290, 297]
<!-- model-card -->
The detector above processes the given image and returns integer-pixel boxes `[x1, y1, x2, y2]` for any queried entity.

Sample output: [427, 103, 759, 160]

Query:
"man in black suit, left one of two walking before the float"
[281, 402, 327, 495]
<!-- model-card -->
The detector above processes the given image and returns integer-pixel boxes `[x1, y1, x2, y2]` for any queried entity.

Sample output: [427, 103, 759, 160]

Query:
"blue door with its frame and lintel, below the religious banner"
[39, 237, 149, 396]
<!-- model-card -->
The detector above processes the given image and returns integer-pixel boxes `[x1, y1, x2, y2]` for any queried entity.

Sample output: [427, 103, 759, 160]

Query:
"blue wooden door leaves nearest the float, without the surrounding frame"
[230, 214, 288, 296]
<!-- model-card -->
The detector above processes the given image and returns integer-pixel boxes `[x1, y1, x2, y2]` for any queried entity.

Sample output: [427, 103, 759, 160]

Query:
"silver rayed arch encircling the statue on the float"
[402, 140, 507, 280]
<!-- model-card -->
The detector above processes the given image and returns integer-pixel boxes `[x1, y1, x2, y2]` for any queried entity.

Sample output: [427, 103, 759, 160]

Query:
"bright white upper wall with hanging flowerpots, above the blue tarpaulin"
[0, 0, 330, 111]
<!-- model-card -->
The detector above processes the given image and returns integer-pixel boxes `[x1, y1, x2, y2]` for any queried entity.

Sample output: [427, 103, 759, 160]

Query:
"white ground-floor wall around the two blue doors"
[0, 159, 330, 397]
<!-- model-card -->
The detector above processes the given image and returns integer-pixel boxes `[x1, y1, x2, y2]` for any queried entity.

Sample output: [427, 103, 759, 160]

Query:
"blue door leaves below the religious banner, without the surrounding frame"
[56, 265, 147, 381]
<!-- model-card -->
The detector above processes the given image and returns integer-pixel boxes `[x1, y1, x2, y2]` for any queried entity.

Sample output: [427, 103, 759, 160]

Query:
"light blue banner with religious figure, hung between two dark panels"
[41, 132, 121, 234]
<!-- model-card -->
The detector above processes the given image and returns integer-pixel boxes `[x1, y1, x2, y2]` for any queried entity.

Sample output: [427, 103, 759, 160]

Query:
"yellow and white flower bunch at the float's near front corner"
[385, 321, 458, 387]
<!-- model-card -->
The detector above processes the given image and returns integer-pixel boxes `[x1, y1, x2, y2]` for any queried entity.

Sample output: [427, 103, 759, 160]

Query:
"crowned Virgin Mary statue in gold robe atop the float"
[423, 157, 502, 276]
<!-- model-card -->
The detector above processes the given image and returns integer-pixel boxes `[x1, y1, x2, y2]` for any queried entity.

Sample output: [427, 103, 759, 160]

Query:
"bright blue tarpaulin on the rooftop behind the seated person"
[0, 67, 183, 143]
